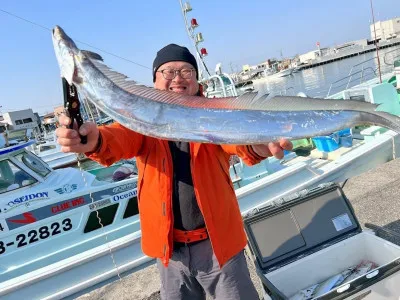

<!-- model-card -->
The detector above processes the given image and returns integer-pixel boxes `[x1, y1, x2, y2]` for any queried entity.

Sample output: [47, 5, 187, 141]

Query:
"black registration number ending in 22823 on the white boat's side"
[0, 218, 72, 255]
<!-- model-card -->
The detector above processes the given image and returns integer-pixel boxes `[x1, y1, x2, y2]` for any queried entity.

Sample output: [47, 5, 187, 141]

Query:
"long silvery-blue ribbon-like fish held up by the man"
[52, 26, 400, 145]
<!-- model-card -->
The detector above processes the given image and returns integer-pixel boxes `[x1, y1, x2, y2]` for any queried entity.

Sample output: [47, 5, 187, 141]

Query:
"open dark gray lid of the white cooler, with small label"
[243, 183, 361, 272]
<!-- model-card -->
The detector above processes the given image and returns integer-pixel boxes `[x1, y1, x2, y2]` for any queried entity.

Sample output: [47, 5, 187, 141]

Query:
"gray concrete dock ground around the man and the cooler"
[73, 159, 400, 300]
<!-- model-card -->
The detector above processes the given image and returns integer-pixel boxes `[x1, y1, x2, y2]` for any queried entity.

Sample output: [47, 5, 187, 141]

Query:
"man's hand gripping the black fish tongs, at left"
[56, 115, 99, 153]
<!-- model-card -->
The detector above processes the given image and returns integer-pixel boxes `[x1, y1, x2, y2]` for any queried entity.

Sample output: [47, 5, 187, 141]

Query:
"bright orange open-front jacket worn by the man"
[88, 123, 263, 266]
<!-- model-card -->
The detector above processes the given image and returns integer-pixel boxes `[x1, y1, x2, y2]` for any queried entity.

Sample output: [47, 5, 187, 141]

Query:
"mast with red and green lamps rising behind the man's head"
[179, 0, 211, 81]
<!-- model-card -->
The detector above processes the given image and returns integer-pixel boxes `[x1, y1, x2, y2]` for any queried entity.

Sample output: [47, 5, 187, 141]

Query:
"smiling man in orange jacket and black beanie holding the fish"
[56, 44, 292, 300]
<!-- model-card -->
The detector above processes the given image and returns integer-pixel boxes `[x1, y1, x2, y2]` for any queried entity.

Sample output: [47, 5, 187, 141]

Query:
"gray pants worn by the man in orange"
[157, 239, 259, 300]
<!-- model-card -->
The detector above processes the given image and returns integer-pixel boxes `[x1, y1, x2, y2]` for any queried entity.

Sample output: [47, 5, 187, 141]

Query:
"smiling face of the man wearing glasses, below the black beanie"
[154, 61, 199, 96]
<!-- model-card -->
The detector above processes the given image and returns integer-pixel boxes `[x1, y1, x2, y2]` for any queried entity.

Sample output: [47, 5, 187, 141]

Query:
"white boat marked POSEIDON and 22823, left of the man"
[0, 141, 144, 299]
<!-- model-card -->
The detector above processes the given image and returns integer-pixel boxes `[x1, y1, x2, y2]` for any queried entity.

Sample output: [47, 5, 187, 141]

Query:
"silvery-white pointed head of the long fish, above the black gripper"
[52, 26, 80, 85]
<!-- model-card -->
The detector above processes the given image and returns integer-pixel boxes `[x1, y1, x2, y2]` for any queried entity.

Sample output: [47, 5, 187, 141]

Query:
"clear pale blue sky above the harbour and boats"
[0, 0, 400, 114]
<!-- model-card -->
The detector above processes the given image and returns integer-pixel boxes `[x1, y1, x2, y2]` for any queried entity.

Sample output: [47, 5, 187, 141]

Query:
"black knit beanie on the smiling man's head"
[153, 44, 199, 82]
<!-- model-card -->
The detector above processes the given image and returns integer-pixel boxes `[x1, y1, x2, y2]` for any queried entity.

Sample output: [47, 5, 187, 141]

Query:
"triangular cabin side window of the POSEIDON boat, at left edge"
[0, 159, 37, 193]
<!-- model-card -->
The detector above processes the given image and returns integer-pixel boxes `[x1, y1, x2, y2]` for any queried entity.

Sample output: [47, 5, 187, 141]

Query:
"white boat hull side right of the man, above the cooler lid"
[237, 131, 400, 213]
